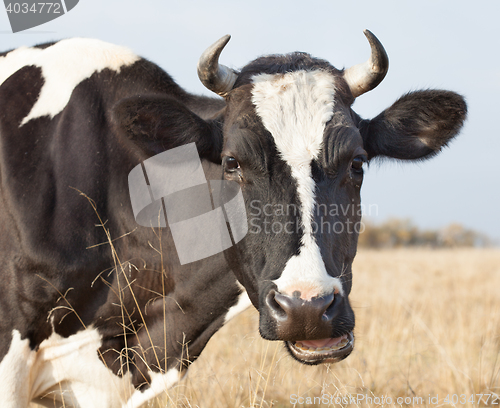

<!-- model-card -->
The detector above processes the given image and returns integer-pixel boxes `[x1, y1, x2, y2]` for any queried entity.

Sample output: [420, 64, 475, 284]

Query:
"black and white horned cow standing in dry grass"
[0, 31, 466, 408]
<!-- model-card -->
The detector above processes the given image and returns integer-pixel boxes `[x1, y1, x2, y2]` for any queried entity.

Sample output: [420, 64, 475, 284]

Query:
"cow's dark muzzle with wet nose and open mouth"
[261, 290, 354, 364]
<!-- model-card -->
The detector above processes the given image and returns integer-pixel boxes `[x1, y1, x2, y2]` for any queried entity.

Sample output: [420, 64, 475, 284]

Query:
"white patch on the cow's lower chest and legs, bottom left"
[0, 328, 181, 408]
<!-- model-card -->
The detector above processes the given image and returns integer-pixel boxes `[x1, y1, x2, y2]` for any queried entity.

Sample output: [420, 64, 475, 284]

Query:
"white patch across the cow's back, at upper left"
[0, 38, 139, 126]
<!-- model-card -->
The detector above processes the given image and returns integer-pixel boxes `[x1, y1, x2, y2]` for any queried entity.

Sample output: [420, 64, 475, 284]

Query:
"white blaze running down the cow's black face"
[252, 71, 343, 299]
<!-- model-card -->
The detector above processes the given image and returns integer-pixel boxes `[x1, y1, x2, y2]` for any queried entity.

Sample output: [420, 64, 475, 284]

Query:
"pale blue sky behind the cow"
[0, 0, 500, 239]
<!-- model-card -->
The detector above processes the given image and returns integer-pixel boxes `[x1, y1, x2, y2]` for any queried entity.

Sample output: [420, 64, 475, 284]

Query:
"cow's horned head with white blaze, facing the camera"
[115, 31, 466, 364]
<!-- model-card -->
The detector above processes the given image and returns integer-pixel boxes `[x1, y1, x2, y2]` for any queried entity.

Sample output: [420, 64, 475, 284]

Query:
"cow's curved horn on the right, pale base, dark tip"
[344, 30, 389, 98]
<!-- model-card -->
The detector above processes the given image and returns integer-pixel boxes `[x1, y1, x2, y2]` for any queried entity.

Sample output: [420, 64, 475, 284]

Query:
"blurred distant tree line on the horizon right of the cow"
[358, 218, 493, 248]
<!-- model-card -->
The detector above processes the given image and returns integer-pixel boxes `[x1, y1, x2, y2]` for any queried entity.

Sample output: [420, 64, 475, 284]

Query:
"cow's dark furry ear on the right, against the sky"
[360, 90, 467, 160]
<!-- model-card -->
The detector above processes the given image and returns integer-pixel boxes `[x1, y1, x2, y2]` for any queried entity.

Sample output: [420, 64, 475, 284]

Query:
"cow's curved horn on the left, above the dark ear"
[198, 35, 238, 97]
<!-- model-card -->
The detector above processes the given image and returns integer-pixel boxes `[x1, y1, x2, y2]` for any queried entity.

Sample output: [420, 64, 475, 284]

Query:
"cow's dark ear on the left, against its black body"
[112, 95, 222, 162]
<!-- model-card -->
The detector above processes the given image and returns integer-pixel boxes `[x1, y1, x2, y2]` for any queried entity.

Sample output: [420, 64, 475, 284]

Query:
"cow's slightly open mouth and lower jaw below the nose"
[285, 332, 354, 365]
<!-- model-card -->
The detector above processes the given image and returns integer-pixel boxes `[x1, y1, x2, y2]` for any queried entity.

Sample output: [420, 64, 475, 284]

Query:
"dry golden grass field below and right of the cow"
[155, 249, 500, 408]
